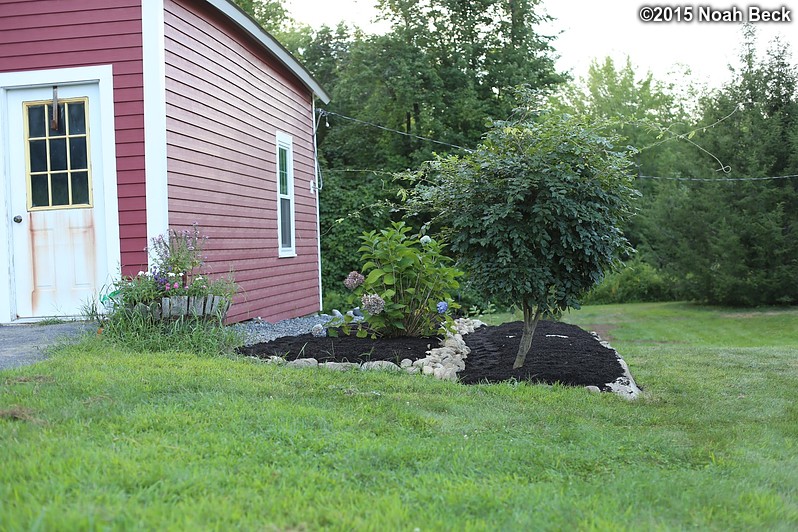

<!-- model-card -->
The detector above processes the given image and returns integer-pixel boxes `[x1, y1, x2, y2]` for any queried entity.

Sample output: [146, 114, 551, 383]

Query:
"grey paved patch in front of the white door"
[0, 322, 92, 370]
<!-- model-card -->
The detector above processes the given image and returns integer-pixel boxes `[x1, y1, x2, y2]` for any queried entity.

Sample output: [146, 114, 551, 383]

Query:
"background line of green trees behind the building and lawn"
[234, 0, 798, 305]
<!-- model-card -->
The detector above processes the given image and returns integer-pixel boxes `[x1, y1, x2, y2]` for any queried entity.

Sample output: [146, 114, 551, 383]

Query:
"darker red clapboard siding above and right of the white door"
[0, 0, 147, 274]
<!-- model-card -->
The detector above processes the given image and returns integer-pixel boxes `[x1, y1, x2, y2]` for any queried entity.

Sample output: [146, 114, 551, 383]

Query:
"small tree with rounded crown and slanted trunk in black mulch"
[410, 95, 639, 368]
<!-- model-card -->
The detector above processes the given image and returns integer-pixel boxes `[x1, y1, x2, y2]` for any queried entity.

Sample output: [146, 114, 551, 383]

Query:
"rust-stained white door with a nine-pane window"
[6, 83, 109, 318]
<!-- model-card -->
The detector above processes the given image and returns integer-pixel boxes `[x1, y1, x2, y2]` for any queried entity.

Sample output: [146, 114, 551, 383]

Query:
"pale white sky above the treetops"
[286, 0, 798, 88]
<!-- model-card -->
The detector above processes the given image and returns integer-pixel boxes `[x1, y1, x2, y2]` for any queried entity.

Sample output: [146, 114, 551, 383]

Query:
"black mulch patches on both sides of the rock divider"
[239, 321, 623, 390]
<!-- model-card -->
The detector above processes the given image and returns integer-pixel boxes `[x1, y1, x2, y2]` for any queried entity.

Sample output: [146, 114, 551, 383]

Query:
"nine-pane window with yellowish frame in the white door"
[23, 98, 91, 211]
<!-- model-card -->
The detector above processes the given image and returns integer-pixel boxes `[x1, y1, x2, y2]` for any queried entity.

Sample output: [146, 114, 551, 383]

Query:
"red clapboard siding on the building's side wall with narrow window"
[164, 0, 320, 321]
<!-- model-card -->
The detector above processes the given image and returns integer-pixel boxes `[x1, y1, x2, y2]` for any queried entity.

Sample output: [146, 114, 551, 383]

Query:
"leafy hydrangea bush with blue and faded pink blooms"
[334, 222, 463, 336]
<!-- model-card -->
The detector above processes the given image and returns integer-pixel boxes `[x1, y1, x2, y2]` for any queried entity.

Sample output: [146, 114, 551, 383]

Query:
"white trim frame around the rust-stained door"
[0, 65, 121, 323]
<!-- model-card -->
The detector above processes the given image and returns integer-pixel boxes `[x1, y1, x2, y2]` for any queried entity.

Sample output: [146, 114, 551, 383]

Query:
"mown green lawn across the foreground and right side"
[0, 304, 798, 530]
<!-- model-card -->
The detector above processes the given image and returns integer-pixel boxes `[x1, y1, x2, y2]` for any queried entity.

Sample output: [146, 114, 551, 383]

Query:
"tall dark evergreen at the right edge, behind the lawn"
[648, 27, 798, 305]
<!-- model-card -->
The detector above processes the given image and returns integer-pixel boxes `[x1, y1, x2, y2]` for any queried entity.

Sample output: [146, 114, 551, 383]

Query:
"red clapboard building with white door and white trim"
[0, 0, 329, 323]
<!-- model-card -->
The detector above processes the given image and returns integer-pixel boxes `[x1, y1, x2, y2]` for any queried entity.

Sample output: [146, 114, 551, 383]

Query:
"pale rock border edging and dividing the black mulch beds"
[252, 318, 643, 400]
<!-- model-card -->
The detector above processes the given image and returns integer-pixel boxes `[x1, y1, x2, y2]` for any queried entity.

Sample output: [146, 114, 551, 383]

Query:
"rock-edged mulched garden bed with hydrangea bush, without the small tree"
[238, 222, 639, 397]
